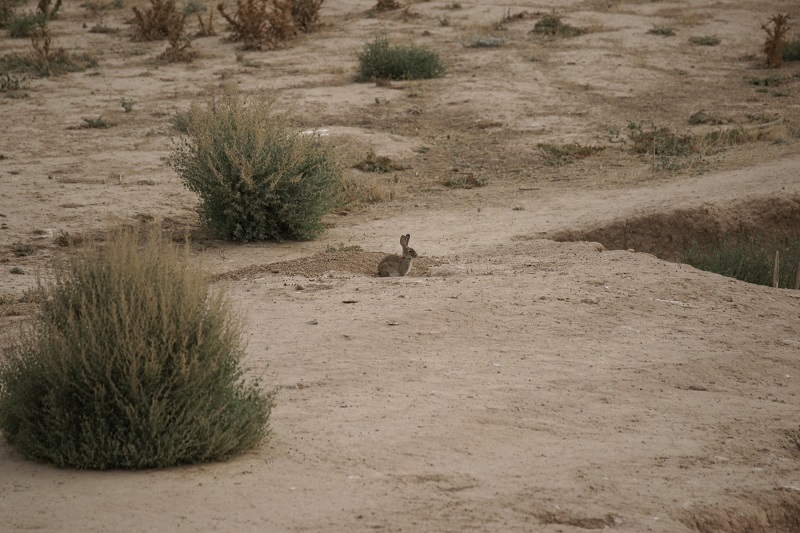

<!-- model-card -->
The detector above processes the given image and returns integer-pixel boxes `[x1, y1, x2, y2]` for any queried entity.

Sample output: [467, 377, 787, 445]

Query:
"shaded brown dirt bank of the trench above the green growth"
[548, 195, 800, 261]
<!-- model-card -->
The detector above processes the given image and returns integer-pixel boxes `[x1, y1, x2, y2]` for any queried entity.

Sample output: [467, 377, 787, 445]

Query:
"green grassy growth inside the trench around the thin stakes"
[682, 237, 800, 288]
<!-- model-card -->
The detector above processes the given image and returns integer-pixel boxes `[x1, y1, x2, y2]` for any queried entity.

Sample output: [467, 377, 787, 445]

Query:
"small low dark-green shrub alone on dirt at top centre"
[356, 34, 445, 81]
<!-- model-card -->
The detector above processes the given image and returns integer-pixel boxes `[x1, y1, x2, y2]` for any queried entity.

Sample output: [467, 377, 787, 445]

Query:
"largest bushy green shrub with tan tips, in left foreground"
[0, 230, 272, 469]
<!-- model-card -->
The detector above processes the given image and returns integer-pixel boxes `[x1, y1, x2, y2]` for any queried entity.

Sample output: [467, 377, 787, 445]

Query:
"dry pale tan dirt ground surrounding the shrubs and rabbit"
[0, 0, 800, 532]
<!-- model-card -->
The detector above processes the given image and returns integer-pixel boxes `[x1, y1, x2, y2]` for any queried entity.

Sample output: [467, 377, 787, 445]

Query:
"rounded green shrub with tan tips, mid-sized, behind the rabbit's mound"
[170, 93, 340, 242]
